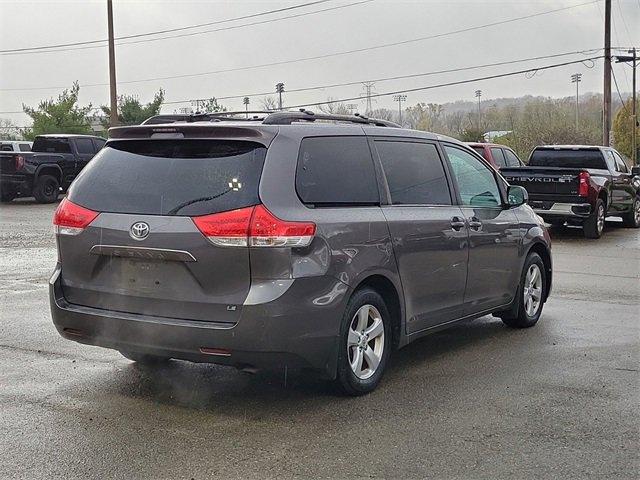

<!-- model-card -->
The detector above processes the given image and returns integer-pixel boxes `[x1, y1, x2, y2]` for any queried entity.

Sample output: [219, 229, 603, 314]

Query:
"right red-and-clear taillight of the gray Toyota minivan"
[193, 205, 316, 247]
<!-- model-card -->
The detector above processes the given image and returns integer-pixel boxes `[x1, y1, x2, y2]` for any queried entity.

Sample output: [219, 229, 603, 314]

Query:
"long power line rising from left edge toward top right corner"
[0, 0, 602, 91]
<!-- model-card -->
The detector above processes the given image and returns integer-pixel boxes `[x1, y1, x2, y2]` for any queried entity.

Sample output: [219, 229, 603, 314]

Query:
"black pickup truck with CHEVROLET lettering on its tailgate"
[500, 145, 640, 238]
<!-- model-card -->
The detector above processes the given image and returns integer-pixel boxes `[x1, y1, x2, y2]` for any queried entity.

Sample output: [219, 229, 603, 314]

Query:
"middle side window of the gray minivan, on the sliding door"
[375, 140, 451, 205]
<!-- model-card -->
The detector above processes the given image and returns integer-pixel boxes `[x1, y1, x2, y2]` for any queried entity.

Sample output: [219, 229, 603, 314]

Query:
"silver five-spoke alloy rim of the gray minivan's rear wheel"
[347, 305, 384, 380]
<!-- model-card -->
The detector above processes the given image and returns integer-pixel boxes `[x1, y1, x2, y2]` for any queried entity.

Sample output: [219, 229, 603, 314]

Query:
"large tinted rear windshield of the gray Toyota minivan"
[69, 140, 266, 216]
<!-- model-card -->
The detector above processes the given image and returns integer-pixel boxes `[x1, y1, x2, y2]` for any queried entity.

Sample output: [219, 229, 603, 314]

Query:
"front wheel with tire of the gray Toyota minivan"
[501, 252, 548, 328]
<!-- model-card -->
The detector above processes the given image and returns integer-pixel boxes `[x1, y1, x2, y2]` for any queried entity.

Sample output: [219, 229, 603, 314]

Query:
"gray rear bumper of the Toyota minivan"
[49, 265, 347, 378]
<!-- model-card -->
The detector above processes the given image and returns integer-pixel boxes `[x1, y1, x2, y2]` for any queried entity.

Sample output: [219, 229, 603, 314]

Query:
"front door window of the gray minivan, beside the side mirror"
[444, 145, 502, 207]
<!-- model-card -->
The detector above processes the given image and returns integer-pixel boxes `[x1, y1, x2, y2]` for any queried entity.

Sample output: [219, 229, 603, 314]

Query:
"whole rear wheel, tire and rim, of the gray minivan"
[336, 288, 392, 396]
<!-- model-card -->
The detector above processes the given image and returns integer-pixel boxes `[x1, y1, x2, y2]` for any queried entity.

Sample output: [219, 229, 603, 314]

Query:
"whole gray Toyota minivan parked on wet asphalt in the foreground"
[50, 112, 551, 395]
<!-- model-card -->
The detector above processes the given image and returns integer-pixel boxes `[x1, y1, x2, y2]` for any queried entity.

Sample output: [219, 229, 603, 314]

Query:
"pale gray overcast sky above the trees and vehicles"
[0, 0, 640, 125]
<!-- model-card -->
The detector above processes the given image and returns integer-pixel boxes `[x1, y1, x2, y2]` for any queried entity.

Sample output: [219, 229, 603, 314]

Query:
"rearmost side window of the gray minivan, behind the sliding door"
[296, 136, 380, 205]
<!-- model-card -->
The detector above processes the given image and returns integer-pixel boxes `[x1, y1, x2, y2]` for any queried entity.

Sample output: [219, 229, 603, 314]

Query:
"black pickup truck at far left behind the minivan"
[0, 134, 106, 203]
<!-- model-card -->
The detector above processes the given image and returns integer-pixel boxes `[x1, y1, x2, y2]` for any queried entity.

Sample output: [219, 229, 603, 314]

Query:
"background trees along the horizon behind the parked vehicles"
[0, 82, 640, 159]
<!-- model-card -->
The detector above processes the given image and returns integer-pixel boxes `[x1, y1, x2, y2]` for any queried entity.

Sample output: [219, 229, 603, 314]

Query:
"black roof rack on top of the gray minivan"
[142, 108, 401, 128]
